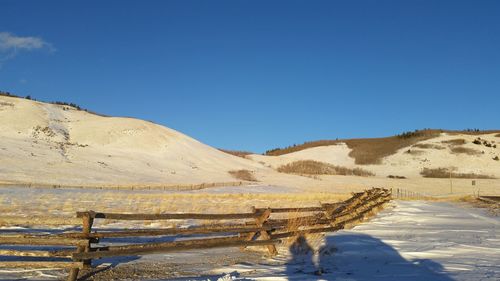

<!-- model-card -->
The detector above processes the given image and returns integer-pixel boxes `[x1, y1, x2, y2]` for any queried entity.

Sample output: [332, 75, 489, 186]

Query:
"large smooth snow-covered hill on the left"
[0, 96, 269, 185]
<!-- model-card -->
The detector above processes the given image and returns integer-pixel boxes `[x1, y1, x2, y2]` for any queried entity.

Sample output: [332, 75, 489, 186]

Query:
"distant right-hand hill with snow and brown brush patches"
[252, 130, 500, 178]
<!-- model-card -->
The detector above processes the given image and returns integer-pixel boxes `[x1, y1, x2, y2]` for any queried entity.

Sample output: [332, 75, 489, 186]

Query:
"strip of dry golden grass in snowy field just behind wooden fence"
[0, 189, 349, 221]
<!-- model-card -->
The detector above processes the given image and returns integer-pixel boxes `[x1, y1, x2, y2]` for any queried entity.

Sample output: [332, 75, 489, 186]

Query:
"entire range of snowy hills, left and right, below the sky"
[0, 96, 500, 192]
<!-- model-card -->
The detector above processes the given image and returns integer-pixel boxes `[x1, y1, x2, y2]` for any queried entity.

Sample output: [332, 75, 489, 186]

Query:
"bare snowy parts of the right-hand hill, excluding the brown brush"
[249, 133, 500, 178]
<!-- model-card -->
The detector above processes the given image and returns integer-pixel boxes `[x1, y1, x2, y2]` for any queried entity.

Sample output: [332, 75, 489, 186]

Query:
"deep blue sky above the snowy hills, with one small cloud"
[0, 0, 500, 152]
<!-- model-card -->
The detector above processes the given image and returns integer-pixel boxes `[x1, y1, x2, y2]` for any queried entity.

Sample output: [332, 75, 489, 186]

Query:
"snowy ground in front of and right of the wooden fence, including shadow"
[0, 201, 500, 281]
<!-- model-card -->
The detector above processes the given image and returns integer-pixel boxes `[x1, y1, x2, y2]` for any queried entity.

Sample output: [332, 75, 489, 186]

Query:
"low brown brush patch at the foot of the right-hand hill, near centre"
[277, 160, 374, 177]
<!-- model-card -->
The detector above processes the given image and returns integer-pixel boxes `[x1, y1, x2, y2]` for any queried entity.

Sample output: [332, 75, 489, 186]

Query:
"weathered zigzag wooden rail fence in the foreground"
[0, 188, 392, 281]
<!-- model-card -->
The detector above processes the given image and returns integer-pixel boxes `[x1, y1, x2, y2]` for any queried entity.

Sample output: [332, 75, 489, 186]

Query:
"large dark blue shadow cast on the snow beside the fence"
[284, 234, 453, 281]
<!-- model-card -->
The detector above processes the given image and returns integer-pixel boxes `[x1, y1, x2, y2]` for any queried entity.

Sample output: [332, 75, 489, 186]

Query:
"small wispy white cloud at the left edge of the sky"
[0, 32, 55, 67]
